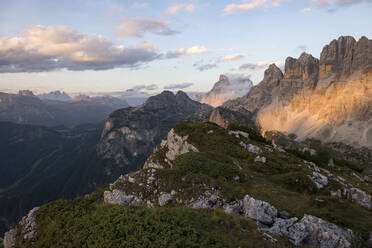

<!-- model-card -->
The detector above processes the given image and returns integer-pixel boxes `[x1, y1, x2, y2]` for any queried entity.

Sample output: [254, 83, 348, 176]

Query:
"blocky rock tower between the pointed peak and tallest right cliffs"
[284, 53, 319, 80]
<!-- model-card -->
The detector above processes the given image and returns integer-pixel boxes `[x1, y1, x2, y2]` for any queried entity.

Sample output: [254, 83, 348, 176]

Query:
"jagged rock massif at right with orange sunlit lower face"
[225, 37, 372, 148]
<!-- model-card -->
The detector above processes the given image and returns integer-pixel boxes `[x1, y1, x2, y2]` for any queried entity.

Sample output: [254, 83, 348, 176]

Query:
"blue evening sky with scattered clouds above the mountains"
[0, 0, 372, 94]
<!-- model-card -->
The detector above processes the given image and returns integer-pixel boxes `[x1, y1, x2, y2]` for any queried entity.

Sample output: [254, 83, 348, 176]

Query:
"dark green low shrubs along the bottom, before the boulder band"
[22, 194, 292, 248]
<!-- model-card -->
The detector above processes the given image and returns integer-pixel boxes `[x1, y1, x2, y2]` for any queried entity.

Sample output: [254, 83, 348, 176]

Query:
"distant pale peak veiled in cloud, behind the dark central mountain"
[193, 75, 253, 107]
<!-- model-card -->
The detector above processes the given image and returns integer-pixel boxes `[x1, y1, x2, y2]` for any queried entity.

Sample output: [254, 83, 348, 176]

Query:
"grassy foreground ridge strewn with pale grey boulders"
[4, 122, 372, 248]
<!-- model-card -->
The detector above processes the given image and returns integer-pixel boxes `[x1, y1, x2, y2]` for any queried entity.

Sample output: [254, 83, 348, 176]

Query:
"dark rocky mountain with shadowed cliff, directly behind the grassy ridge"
[97, 91, 212, 171]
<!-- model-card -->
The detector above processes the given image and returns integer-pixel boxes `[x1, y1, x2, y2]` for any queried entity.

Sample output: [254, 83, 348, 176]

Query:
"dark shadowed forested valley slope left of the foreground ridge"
[0, 122, 117, 234]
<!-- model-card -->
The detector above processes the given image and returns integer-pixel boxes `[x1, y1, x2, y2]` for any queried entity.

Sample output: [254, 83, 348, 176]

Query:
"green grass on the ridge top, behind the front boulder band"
[173, 122, 372, 237]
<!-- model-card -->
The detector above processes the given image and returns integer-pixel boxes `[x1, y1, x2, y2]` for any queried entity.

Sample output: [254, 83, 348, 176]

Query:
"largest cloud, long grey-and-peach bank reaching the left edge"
[0, 25, 159, 73]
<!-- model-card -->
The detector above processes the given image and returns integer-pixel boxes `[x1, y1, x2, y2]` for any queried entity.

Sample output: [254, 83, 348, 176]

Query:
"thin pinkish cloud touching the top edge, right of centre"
[222, 0, 291, 15]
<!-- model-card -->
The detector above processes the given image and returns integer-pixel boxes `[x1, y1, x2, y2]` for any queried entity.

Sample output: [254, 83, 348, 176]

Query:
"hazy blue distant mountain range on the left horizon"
[0, 91, 128, 126]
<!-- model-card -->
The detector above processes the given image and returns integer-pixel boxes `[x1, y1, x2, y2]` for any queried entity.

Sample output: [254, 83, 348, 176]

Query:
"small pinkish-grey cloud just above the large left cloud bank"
[117, 18, 179, 37]
